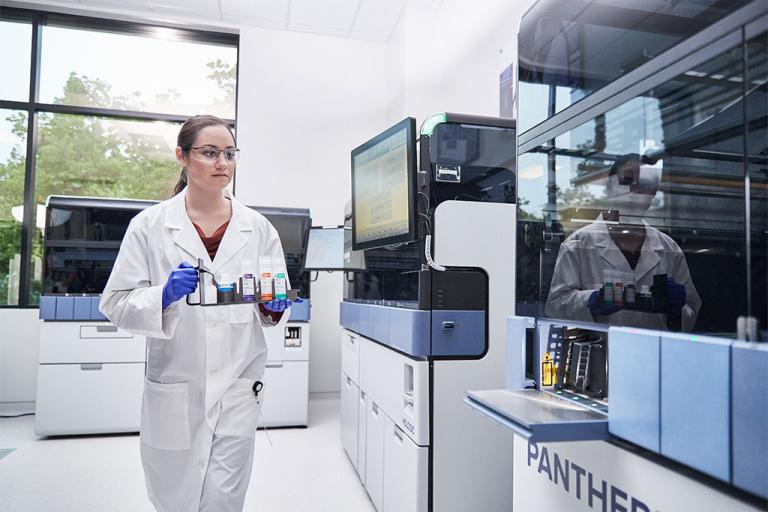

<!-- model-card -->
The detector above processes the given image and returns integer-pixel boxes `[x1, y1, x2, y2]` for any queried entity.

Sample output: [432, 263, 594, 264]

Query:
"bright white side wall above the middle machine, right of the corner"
[387, 0, 533, 123]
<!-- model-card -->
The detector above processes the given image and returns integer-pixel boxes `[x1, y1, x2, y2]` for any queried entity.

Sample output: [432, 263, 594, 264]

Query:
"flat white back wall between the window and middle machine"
[235, 28, 387, 392]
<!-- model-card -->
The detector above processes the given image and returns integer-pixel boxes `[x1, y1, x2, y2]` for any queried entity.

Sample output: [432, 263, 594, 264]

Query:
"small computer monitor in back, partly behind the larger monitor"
[304, 226, 365, 271]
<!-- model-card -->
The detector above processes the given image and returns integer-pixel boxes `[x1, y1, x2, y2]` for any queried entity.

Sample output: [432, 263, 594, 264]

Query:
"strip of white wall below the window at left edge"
[0, 309, 40, 414]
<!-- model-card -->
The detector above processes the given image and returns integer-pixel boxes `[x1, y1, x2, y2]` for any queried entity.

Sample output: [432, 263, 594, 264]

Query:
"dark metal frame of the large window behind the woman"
[0, 8, 240, 309]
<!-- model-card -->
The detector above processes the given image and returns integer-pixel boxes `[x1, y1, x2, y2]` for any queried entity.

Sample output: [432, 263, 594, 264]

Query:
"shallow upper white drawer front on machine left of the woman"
[39, 322, 146, 364]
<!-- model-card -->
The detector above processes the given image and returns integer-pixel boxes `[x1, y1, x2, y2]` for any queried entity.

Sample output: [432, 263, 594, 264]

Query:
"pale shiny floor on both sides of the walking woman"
[0, 395, 375, 512]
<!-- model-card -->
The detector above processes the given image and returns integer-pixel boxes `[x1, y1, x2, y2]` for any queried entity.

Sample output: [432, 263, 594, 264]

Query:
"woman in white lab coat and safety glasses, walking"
[100, 116, 290, 512]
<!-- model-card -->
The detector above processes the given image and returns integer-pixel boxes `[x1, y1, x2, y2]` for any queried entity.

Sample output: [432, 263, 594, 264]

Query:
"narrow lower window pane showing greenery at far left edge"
[0, 109, 28, 305]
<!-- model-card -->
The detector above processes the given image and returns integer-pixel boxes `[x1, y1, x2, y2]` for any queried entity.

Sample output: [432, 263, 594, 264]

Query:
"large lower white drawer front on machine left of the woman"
[35, 363, 144, 436]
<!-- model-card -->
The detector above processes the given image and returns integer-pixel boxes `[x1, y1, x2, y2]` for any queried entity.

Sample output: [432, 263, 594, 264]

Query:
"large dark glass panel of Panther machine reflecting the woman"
[518, 42, 747, 335]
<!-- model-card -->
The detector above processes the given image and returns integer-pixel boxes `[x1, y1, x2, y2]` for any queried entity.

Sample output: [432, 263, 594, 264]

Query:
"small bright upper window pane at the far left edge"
[0, 20, 32, 101]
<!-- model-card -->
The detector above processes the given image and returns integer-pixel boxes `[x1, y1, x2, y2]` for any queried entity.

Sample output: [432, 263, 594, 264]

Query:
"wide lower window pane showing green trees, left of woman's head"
[30, 114, 180, 304]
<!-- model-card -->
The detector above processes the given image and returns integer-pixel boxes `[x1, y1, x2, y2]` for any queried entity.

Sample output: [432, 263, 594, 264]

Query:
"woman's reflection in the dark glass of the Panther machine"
[546, 154, 701, 331]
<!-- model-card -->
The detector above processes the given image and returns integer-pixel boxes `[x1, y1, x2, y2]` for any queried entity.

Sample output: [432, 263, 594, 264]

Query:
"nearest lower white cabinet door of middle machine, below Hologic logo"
[383, 418, 428, 512]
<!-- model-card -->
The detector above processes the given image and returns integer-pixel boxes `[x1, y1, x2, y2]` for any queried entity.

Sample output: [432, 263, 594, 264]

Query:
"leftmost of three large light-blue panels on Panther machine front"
[608, 327, 661, 453]
